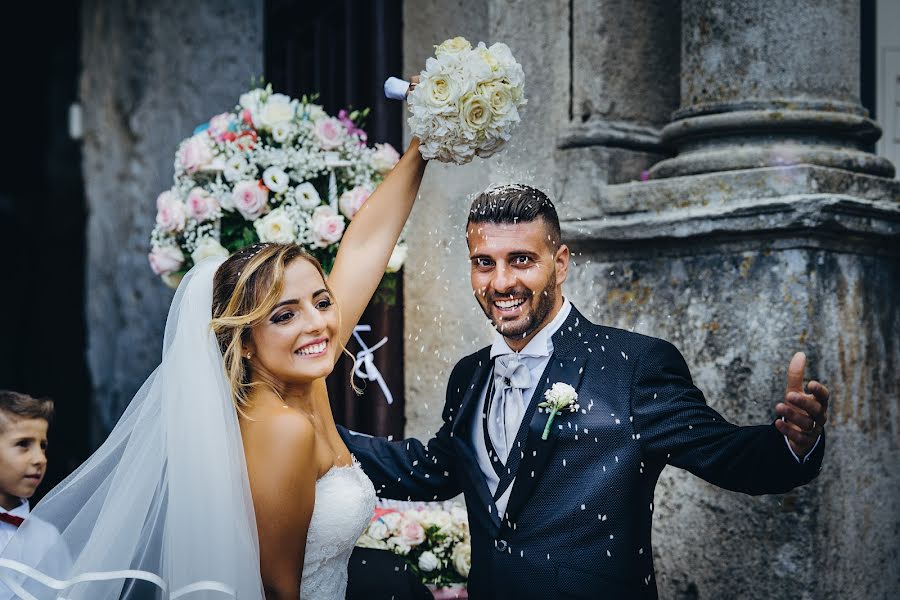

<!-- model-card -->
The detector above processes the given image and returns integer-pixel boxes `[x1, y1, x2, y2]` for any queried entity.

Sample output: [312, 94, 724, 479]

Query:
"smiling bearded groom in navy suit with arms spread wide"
[340, 185, 828, 600]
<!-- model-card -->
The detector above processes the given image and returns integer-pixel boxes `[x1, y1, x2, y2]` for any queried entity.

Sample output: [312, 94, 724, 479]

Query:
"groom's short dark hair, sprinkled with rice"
[466, 183, 562, 248]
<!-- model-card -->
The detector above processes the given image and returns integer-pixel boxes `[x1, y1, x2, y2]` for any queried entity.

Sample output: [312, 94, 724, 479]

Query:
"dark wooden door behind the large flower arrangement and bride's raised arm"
[265, 0, 404, 437]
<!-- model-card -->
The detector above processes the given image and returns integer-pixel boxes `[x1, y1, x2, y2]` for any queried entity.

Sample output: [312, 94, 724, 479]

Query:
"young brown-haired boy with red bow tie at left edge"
[0, 390, 53, 549]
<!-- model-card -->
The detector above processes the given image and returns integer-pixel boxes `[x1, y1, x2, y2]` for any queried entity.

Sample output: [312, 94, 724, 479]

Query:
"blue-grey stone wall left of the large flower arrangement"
[80, 0, 263, 441]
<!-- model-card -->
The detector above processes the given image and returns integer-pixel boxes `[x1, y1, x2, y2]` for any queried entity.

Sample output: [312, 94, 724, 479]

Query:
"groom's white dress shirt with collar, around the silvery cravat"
[472, 298, 572, 517]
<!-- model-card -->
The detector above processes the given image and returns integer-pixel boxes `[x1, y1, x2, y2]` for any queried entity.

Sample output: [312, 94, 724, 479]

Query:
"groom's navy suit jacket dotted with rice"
[341, 307, 824, 600]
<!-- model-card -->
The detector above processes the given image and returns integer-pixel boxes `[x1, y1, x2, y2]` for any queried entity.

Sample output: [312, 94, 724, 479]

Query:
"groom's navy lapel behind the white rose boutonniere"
[506, 306, 587, 523]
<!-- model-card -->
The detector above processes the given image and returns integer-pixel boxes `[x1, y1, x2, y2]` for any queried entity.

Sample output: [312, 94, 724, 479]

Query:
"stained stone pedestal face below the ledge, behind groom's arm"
[568, 239, 900, 599]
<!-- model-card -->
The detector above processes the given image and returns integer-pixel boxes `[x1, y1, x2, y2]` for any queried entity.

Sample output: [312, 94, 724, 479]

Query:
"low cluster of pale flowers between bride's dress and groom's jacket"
[356, 505, 472, 587]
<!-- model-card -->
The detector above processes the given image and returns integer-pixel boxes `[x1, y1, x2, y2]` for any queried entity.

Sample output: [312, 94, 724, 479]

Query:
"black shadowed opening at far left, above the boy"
[0, 1, 90, 500]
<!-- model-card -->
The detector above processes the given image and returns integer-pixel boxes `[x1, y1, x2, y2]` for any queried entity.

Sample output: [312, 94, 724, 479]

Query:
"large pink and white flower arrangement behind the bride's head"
[149, 85, 406, 287]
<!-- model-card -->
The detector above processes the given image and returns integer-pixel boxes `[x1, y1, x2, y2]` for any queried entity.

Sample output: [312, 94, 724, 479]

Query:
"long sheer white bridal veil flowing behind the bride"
[0, 259, 264, 600]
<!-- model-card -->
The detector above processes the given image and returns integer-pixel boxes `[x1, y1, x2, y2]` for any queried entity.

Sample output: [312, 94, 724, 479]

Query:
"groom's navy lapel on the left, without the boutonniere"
[451, 347, 500, 531]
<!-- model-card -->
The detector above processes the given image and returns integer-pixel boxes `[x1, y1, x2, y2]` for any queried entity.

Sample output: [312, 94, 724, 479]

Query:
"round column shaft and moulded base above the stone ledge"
[651, 0, 894, 177]
